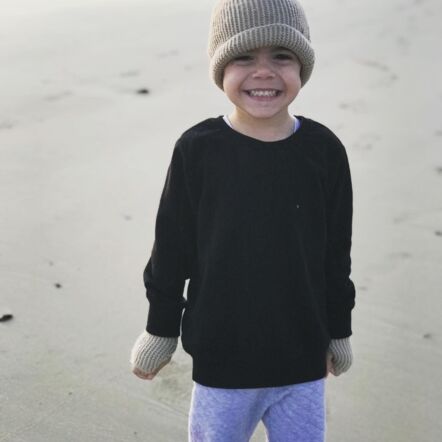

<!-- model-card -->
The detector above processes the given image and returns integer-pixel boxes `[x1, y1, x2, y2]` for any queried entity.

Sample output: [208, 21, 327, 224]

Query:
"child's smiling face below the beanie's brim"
[223, 47, 301, 121]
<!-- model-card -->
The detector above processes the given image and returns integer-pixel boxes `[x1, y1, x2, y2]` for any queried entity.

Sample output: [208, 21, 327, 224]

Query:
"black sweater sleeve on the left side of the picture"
[143, 141, 192, 337]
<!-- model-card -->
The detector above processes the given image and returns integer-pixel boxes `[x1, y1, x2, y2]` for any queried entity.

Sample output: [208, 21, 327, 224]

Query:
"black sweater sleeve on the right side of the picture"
[325, 143, 355, 339]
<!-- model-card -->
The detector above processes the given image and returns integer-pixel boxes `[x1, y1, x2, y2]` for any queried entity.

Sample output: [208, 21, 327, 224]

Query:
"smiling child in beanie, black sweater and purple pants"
[131, 0, 355, 442]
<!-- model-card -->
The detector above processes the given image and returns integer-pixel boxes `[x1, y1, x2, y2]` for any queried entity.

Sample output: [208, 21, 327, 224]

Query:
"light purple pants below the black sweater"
[189, 378, 325, 442]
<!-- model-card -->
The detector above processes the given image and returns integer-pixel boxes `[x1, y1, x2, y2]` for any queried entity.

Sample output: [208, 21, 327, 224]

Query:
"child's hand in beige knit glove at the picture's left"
[130, 331, 178, 380]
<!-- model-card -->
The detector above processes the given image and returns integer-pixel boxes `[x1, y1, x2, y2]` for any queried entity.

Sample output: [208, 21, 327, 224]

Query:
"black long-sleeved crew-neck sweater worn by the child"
[144, 116, 355, 388]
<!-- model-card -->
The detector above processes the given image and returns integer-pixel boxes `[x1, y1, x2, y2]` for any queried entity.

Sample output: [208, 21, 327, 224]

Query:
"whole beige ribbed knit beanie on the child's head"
[208, 0, 315, 89]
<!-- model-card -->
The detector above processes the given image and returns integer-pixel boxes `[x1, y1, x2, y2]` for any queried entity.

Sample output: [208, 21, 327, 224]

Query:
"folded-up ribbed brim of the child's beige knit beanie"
[210, 24, 315, 89]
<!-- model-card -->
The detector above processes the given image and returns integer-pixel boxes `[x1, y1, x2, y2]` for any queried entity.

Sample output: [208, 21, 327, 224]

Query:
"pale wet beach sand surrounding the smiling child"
[0, 0, 442, 442]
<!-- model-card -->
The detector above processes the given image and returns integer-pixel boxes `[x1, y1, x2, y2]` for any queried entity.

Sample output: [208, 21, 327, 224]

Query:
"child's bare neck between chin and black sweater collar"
[229, 109, 295, 141]
